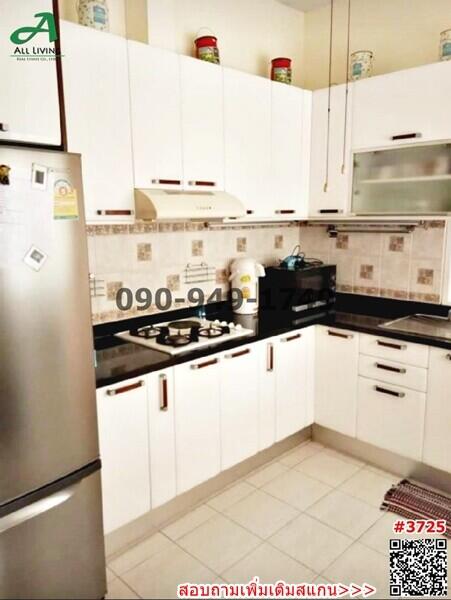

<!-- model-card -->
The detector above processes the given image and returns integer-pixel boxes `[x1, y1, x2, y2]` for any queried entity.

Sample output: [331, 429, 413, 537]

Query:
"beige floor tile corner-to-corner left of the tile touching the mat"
[224, 490, 299, 538]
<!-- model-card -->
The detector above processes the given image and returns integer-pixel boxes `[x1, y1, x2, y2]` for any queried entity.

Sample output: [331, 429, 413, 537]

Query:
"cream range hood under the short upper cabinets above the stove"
[135, 189, 246, 221]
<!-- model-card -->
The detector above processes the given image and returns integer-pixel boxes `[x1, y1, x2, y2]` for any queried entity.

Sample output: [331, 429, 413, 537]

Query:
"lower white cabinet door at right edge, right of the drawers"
[423, 348, 451, 472]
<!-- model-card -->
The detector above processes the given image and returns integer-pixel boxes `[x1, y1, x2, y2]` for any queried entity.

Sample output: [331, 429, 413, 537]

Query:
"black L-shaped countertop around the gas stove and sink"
[94, 294, 451, 388]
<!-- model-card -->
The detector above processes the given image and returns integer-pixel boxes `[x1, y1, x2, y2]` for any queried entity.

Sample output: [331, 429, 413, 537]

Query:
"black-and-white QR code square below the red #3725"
[390, 538, 448, 597]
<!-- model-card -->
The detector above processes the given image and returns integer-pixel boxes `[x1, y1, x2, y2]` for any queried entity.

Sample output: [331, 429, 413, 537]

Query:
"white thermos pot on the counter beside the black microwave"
[229, 258, 265, 315]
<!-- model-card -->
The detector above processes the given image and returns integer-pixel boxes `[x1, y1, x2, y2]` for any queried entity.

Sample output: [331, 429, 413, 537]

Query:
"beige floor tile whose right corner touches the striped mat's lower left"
[307, 490, 383, 539]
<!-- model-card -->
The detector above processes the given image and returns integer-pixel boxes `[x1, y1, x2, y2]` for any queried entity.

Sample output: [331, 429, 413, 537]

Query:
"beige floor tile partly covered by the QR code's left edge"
[322, 542, 390, 598]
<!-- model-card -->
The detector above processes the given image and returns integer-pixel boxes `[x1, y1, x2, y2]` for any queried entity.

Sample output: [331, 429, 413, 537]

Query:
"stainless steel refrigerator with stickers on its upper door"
[0, 146, 106, 599]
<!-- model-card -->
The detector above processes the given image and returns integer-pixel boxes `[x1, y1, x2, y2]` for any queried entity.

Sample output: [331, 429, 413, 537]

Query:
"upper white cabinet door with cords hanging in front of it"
[309, 85, 353, 217]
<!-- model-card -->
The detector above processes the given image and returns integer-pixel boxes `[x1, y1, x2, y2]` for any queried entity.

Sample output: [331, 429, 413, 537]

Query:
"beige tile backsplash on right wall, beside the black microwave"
[299, 221, 445, 303]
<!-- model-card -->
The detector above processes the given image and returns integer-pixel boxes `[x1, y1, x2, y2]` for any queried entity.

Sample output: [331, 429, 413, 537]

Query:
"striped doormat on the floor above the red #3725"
[381, 479, 451, 537]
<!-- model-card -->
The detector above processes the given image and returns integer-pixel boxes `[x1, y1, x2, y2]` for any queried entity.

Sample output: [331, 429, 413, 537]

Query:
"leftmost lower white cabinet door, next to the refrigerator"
[97, 379, 150, 533]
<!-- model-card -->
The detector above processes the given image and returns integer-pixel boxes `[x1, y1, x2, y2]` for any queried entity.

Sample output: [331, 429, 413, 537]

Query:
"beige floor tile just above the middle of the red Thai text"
[223, 544, 316, 583]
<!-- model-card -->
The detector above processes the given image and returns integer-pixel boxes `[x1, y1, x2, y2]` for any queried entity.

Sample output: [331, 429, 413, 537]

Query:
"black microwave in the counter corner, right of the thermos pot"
[259, 265, 337, 314]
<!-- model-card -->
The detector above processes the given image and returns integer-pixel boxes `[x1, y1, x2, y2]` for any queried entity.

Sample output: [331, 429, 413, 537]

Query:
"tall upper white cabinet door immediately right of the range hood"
[224, 69, 274, 216]
